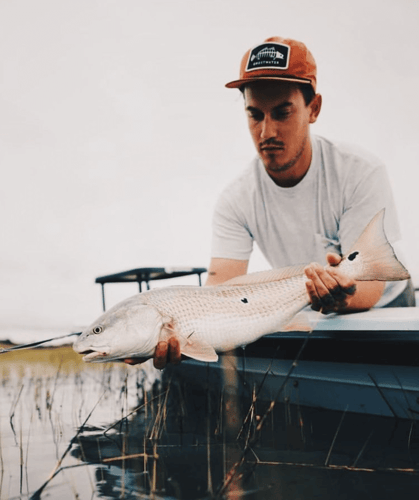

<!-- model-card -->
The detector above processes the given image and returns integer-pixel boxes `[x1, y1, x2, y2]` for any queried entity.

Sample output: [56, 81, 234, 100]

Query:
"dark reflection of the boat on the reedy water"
[72, 370, 419, 500]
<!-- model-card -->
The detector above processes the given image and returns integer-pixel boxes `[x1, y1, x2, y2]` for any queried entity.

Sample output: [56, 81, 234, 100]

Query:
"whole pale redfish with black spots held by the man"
[73, 210, 410, 362]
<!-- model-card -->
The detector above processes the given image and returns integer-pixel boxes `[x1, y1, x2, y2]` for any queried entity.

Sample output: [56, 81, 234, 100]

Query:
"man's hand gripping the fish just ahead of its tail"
[304, 253, 357, 314]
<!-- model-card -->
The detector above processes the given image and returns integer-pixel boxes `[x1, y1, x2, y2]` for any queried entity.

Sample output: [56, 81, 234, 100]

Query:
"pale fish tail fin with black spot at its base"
[344, 209, 410, 281]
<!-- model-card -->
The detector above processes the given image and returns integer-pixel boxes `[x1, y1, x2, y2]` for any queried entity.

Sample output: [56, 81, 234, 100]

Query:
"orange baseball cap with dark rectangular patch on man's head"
[226, 36, 317, 91]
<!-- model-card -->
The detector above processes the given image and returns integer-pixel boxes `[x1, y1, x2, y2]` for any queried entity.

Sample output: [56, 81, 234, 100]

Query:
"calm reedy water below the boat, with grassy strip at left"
[0, 348, 419, 500]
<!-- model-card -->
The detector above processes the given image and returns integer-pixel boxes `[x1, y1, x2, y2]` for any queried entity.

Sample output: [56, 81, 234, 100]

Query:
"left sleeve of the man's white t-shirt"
[211, 190, 253, 260]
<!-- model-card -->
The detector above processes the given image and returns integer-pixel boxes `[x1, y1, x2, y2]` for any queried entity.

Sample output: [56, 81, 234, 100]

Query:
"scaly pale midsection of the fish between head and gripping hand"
[142, 276, 308, 352]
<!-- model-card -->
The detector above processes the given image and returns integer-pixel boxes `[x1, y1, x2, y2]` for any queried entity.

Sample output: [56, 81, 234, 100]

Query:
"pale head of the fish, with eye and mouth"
[73, 295, 163, 363]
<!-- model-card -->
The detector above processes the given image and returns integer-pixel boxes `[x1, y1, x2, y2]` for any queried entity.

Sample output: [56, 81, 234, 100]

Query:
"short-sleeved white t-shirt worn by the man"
[211, 136, 406, 306]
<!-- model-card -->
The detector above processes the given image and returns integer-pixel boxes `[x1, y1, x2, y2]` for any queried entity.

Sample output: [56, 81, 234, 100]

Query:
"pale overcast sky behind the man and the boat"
[0, 0, 419, 336]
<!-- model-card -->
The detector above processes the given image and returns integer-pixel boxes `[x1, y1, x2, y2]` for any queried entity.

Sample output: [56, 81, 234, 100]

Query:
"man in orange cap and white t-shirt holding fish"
[126, 37, 414, 368]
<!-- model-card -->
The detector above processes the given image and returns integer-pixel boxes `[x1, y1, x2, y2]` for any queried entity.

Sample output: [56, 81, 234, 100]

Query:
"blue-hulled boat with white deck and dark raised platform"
[96, 268, 419, 421]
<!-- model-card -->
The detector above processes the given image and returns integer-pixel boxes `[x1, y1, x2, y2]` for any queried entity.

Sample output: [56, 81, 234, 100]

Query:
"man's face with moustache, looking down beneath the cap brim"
[244, 81, 321, 185]
